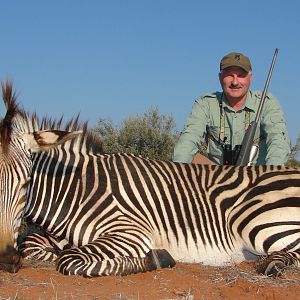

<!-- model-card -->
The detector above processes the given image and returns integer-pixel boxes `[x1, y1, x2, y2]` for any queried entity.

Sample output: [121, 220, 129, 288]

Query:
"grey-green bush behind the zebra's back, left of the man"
[95, 108, 179, 160]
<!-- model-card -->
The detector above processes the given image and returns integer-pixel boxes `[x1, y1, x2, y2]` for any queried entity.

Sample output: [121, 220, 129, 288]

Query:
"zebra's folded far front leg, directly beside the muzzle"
[19, 233, 70, 262]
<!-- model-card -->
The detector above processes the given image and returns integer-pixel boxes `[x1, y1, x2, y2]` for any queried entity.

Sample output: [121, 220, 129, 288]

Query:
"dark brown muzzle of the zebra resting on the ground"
[0, 246, 22, 273]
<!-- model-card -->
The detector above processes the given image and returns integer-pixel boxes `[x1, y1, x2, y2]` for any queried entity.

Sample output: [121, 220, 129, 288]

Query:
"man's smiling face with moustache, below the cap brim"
[219, 67, 252, 102]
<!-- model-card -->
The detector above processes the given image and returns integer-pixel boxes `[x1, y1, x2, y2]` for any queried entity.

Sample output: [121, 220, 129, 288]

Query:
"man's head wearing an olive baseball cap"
[219, 52, 252, 108]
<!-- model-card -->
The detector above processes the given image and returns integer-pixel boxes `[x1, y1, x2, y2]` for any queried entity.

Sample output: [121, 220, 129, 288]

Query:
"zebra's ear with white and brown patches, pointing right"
[22, 130, 82, 153]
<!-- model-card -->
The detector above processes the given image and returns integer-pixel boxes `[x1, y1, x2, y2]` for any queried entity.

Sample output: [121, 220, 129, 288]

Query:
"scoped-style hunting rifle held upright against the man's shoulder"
[235, 48, 278, 166]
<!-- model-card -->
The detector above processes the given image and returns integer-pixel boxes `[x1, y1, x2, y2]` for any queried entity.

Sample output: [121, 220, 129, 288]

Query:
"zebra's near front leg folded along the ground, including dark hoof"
[57, 247, 175, 277]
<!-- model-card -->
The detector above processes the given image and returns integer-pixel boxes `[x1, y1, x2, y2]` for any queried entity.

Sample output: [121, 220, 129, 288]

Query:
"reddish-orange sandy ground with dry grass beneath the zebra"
[0, 262, 300, 300]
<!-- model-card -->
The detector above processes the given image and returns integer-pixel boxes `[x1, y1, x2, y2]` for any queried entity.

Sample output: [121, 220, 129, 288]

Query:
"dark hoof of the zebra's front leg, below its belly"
[146, 249, 176, 270]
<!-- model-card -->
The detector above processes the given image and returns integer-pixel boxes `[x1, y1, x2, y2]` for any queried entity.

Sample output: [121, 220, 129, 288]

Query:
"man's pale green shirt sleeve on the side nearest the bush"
[173, 98, 209, 163]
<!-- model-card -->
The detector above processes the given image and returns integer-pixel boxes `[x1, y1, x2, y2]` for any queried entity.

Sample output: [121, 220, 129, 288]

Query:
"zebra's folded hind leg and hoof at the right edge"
[256, 251, 300, 277]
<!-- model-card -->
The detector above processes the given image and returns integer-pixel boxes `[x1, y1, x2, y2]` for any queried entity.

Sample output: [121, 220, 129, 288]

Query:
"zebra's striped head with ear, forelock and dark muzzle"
[0, 82, 81, 272]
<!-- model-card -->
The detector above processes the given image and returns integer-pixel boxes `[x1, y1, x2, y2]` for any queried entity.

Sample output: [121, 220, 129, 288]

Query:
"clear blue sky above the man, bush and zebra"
[0, 0, 300, 144]
